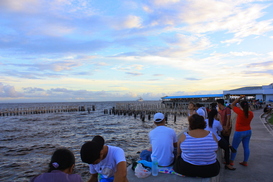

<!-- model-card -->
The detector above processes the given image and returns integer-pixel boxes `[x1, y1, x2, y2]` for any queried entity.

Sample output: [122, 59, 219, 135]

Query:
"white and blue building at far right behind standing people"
[223, 83, 273, 102]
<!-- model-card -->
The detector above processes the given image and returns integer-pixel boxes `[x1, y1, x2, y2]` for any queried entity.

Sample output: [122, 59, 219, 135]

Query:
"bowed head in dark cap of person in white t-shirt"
[80, 135, 104, 164]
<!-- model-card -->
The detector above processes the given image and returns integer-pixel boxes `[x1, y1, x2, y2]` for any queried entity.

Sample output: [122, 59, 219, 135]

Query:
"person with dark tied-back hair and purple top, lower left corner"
[30, 148, 83, 182]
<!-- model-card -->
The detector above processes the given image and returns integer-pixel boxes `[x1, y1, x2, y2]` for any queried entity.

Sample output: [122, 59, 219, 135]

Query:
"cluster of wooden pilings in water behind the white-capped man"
[104, 103, 187, 122]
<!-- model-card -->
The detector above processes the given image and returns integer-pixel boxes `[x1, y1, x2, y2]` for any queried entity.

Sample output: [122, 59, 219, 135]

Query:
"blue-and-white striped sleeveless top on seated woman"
[180, 132, 218, 165]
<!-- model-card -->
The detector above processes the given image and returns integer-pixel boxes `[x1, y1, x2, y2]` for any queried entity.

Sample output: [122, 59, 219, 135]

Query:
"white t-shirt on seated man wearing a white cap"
[149, 126, 177, 166]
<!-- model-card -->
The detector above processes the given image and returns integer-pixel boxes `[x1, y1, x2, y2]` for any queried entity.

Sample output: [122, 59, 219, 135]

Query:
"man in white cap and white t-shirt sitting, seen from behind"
[140, 113, 177, 166]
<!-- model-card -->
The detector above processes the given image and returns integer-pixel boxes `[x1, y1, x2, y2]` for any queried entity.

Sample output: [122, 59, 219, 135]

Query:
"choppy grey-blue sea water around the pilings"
[0, 102, 188, 182]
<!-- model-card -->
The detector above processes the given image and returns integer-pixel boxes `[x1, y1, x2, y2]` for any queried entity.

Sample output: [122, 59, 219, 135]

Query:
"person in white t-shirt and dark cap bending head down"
[80, 135, 128, 182]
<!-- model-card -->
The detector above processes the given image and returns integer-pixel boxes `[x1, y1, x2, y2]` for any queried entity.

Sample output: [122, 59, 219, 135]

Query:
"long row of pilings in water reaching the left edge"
[0, 105, 96, 116]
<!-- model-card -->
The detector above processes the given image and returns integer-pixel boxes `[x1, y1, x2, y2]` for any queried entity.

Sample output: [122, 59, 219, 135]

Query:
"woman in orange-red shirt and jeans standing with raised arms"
[230, 95, 254, 166]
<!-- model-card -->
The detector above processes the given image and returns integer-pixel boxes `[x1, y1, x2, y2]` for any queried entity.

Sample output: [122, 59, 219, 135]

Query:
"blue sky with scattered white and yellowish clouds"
[0, 0, 273, 103]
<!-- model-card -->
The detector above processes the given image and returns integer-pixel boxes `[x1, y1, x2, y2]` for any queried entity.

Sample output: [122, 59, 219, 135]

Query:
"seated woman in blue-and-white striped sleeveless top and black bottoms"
[173, 114, 220, 178]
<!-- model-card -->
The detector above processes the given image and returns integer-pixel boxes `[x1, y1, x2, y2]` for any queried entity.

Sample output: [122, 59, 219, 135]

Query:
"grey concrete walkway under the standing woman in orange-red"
[220, 109, 273, 182]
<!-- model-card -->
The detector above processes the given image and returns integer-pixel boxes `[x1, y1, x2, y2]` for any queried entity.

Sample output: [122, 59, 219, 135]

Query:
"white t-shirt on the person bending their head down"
[89, 145, 126, 178]
